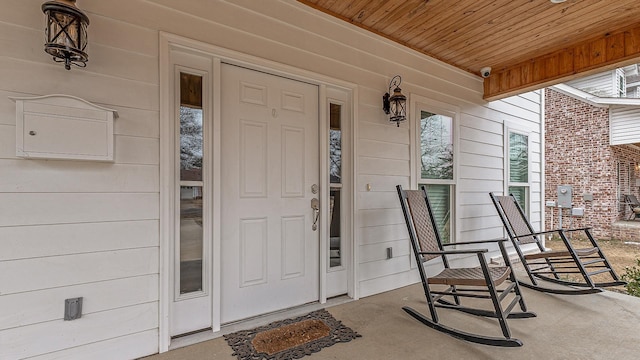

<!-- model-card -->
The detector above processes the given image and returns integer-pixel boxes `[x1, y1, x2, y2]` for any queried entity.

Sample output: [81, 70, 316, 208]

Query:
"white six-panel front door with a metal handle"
[221, 64, 322, 323]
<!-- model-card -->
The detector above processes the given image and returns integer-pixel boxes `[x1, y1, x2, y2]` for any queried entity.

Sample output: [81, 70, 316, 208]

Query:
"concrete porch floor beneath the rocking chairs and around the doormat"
[145, 284, 640, 360]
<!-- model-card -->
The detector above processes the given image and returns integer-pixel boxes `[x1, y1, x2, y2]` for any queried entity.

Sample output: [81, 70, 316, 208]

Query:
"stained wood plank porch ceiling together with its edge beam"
[298, 0, 640, 100]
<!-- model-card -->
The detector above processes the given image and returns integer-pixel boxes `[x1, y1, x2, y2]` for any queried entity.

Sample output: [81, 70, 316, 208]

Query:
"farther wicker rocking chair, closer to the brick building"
[490, 193, 626, 295]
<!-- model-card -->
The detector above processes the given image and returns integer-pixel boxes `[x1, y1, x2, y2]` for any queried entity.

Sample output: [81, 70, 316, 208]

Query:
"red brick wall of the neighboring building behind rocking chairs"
[545, 89, 640, 239]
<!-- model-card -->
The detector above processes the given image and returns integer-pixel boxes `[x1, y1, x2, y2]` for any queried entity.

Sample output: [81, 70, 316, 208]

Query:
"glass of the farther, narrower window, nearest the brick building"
[507, 131, 530, 214]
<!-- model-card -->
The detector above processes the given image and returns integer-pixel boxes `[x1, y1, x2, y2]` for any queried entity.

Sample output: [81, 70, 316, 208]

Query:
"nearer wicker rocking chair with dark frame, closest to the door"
[396, 185, 536, 347]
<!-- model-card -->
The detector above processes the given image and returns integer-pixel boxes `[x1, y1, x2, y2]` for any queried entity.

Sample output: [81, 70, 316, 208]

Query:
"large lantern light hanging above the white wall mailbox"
[42, 0, 89, 70]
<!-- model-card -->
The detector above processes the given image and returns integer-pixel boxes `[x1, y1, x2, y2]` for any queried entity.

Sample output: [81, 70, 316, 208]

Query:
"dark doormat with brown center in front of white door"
[224, 309, 361, 360]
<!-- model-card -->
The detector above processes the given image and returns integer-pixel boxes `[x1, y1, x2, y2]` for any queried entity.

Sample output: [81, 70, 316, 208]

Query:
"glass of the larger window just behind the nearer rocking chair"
[418, 110, 455, 243]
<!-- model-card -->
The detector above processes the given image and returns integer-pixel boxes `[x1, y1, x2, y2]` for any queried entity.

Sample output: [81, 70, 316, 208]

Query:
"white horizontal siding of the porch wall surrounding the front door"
[0, 0, 542, 359]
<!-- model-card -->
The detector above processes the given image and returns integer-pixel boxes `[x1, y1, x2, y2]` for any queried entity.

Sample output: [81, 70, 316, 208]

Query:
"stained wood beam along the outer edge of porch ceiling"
[484, 24, 640, 101]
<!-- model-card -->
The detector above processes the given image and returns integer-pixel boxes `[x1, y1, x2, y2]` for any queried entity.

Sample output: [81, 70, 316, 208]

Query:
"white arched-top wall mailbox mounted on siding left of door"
[11, 95, 118, 161]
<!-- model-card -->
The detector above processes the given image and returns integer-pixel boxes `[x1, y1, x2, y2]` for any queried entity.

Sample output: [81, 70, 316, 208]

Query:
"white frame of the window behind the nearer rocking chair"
[409, 94, 460, 243]
